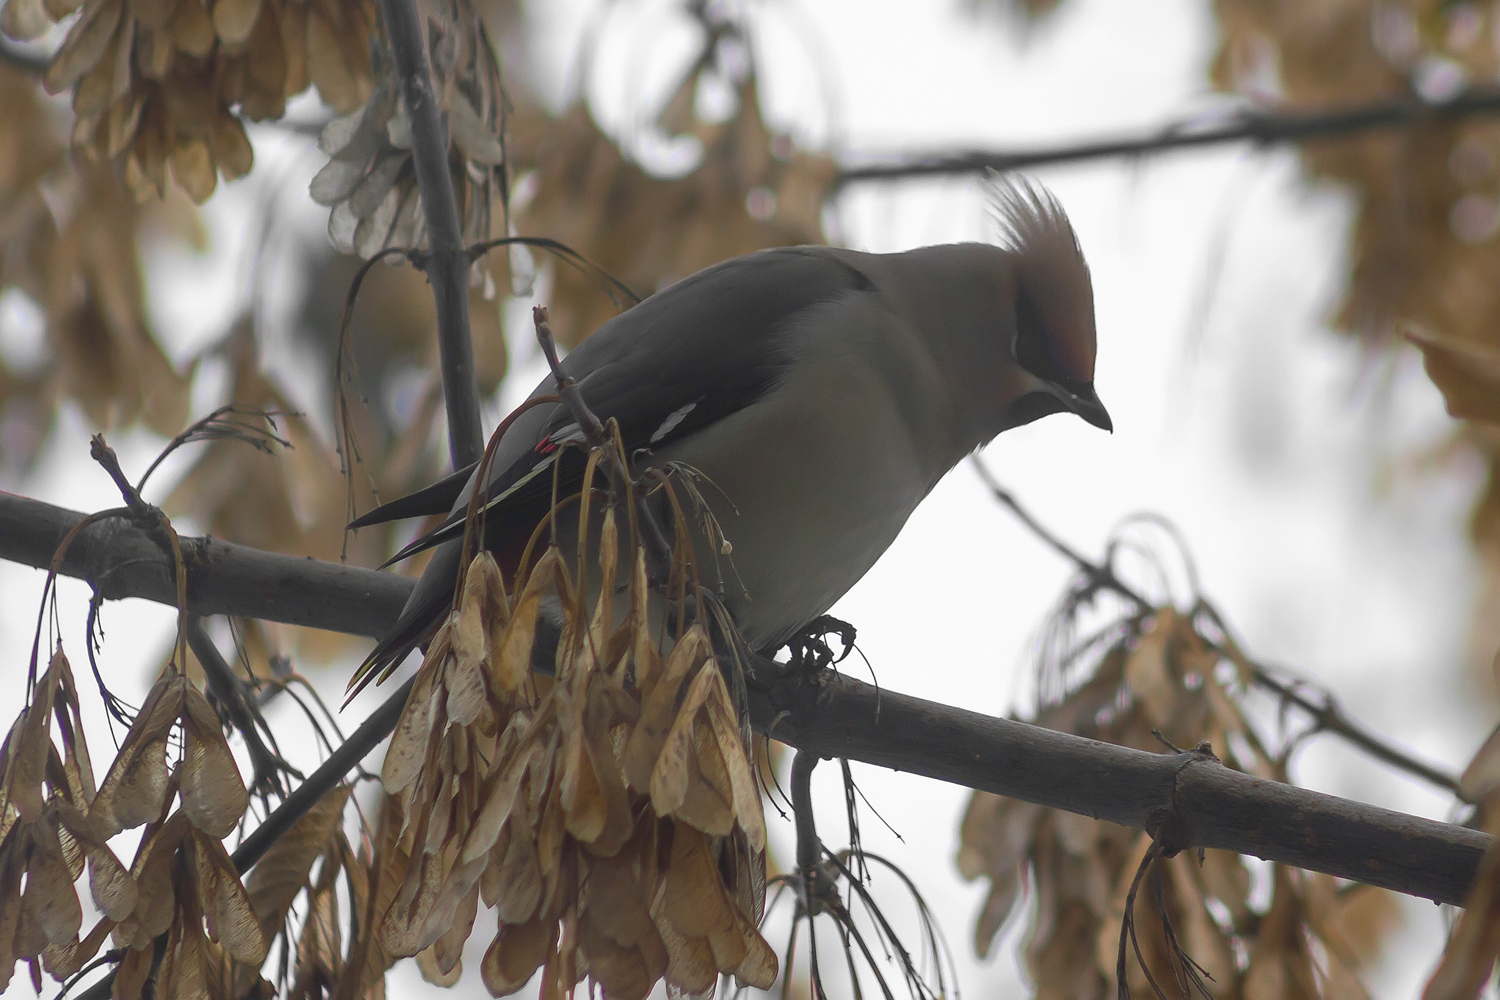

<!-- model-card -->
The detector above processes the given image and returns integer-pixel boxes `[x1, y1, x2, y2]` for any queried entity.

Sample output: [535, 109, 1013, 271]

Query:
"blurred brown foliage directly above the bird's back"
[512, 15, 837, 346]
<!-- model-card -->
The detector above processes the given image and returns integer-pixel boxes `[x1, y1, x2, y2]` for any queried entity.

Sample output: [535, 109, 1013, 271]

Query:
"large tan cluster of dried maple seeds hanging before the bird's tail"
[380, 513, 777, 1000]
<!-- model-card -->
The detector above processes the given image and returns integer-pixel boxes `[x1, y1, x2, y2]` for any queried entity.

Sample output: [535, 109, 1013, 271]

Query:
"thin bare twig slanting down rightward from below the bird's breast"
[974, 459, 1458, 793]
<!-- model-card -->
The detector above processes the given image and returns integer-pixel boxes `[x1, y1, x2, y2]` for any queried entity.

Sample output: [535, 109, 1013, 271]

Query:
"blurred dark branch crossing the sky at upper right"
[834, 87, 1500, 186]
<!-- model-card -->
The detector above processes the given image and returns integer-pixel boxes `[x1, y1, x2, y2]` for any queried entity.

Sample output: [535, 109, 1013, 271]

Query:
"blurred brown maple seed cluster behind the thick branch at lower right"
[959, 607, 1395, 1000]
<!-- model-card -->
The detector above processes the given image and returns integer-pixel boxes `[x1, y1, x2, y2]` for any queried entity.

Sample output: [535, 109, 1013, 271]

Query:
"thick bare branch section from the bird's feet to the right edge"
[752, 675, 1490, 906]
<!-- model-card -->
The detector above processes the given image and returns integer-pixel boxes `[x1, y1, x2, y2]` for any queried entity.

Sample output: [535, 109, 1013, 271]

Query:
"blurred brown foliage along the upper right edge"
[1211, 0, 1500, 689]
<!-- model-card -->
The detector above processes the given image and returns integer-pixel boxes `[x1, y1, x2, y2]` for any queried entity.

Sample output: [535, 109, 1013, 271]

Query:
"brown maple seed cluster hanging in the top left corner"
[0, 0, 377, 202]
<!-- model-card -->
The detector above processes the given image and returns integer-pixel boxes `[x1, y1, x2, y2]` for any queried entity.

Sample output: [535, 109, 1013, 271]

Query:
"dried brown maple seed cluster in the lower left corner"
[0, 651, 266, 1000]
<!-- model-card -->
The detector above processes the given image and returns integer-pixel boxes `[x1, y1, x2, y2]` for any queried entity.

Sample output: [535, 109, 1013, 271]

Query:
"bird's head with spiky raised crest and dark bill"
[992, 175, 1115, 430]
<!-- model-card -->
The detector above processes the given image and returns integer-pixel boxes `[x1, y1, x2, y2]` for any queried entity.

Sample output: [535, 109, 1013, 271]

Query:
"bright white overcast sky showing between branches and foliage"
[0, 0, 1494, 997]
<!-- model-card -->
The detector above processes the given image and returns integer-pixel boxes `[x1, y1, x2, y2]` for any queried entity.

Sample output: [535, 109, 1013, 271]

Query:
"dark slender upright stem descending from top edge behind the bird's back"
[381, 0, 485, 469]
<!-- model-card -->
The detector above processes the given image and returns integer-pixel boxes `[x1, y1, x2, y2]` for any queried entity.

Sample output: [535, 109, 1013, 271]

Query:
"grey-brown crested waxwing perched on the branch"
[351, 178, 1113, 688]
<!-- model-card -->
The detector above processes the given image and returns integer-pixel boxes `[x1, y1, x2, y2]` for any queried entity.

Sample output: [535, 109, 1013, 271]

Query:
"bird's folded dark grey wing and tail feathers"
[351, 247, 875, 687]
